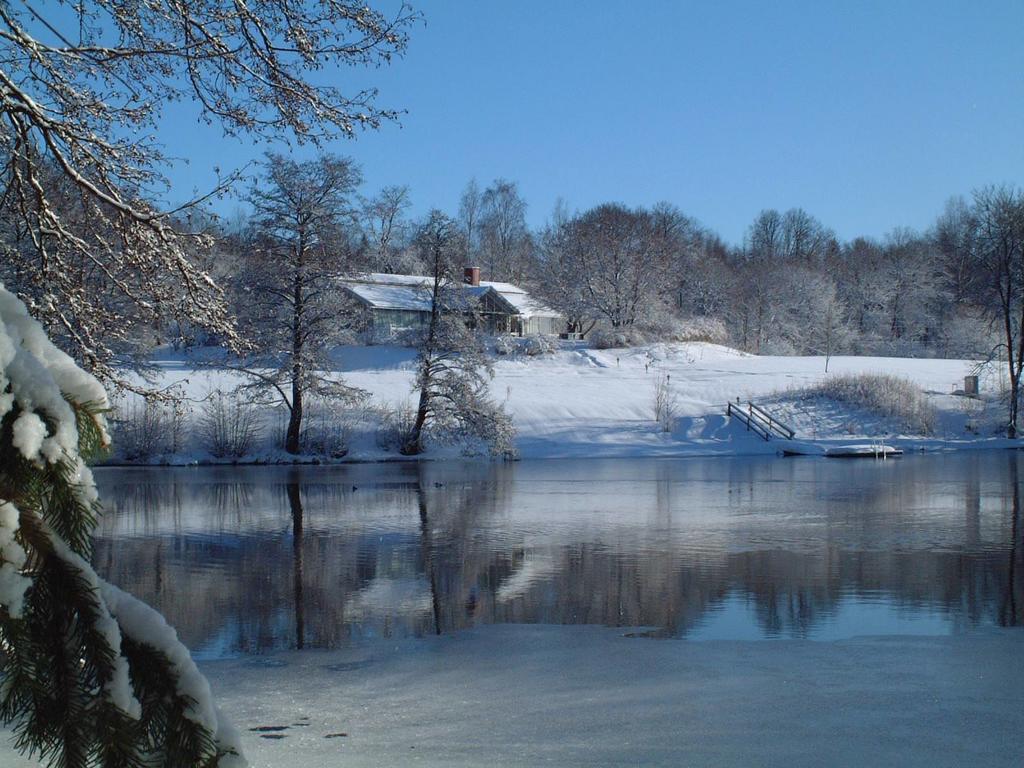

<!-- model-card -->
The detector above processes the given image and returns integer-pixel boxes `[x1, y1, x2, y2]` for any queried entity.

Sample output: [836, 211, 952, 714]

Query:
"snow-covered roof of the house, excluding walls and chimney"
[342, 272, 561, 317]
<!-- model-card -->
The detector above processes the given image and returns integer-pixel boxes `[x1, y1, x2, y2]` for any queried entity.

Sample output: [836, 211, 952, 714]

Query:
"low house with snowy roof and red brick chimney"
[342, 267, 565, 342]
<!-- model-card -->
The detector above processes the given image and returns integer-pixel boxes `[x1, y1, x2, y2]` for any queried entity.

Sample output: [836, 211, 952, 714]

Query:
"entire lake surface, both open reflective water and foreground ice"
[0, 452, 1024, 768]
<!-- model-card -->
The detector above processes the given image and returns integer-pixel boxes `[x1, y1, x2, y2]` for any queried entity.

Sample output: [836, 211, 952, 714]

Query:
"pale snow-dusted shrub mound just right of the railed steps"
[807, 374, 936, 434]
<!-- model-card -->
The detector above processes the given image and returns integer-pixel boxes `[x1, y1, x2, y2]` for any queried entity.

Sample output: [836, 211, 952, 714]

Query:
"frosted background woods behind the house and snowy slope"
[190, 159, 1024, 366]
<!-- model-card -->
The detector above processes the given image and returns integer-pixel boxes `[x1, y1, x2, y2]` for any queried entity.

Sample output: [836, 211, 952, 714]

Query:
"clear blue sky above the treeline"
[155, 0, 1024, 243]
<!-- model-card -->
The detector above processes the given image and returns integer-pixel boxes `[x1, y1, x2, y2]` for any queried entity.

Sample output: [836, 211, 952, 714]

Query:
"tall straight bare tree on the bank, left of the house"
[244, 154, 360, 454]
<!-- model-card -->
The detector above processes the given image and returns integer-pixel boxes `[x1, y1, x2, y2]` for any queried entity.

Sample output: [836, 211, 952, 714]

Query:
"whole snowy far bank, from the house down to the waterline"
[104, 342, 1024, 466]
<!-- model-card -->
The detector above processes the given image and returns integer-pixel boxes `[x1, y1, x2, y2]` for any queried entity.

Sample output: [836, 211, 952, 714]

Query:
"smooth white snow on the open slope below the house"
[123, 342, 1008, 461]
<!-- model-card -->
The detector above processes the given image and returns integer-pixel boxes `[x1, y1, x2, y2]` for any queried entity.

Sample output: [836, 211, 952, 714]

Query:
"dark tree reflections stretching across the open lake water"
[96, 456, 1024, 652]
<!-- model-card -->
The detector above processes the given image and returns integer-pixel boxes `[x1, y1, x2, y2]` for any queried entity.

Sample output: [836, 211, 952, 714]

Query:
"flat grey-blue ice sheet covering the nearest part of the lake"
[6, 625, 1024, 768]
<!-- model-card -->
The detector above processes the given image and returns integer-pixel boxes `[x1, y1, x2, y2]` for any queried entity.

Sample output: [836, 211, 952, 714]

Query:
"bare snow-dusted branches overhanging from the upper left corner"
[0, 0, 417, 381]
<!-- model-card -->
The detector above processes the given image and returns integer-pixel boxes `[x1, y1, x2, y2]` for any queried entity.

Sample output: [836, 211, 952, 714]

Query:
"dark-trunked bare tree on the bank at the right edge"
[971, 186, 1024, 437]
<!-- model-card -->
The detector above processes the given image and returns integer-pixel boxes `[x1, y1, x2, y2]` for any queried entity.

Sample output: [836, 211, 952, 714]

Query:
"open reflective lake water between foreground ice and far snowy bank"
[93, 452, 1024, 658]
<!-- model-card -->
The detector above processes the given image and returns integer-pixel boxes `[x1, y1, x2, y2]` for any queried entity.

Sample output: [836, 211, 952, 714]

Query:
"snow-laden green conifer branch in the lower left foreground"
[0, 284, 245, 766]
